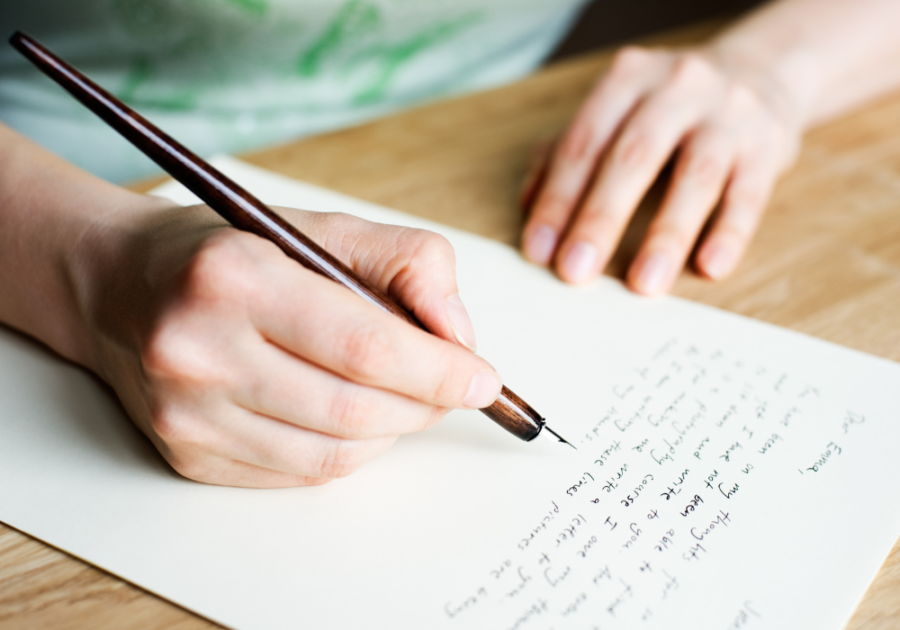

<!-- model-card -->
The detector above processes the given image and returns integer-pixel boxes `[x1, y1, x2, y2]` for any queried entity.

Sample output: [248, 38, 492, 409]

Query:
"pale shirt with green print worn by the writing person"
[0, 0, 584, 182]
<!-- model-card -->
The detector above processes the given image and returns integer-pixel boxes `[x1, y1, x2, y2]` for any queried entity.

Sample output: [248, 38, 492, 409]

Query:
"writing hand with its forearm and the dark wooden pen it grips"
[4, 34, 576, 487]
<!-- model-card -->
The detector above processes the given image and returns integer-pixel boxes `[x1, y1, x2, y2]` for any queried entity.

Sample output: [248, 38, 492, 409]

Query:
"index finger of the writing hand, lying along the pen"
[249, 247, 501, 408]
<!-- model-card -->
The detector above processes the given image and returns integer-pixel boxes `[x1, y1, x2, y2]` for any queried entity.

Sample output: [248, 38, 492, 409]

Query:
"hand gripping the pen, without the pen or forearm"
[76, 202, 501, 487]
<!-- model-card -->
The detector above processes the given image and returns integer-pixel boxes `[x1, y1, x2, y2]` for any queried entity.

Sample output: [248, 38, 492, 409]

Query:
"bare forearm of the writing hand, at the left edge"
[0, 125, 162, 369]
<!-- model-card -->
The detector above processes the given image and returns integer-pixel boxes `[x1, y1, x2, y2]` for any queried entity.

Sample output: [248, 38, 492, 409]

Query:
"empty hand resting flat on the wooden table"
[523, 44, 801, 294]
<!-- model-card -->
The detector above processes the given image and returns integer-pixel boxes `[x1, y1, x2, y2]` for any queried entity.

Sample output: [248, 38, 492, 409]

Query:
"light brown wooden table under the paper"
[0, 19, 900, 630]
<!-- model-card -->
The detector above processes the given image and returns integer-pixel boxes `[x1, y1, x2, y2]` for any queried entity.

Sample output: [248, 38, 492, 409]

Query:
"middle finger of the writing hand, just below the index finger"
[233, 343, 447, 440]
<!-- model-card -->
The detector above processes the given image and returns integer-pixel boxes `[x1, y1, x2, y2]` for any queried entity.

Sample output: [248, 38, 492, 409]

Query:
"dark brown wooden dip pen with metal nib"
[9, 32, 575, 448]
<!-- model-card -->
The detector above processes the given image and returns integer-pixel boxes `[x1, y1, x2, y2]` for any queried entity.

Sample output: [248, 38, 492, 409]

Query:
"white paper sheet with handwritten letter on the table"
[0, 154, 900, 630]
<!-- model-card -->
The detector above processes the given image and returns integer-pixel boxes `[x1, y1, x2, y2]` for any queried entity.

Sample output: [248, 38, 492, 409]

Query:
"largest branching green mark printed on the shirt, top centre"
[297, 0, 480, 105]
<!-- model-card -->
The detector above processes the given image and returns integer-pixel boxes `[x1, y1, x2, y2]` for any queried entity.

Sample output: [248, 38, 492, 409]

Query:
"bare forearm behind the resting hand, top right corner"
[711, 0, 900, 128]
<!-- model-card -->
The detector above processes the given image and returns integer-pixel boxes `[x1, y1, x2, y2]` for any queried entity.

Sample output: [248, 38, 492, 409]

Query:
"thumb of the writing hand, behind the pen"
[279, 209, 476, 352]
